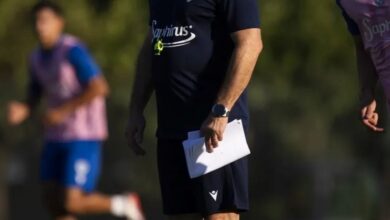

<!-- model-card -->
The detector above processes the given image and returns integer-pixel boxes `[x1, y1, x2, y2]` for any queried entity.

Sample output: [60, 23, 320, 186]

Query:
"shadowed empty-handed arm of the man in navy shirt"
[125, 34, 154, 155]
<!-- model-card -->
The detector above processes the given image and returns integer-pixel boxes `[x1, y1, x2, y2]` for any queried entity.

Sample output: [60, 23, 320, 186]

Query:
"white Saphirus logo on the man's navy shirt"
[152, 20, 196, 55]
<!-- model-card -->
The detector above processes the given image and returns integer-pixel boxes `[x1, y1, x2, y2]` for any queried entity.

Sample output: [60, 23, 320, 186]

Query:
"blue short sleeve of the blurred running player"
[68, 45, 101, 86]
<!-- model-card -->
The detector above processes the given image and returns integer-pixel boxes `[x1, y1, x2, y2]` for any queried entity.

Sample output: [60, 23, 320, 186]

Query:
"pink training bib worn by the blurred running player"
[30, 35, 107, 141]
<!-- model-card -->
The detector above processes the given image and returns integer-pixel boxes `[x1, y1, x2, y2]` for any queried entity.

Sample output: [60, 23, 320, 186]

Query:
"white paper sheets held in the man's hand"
[183, 120, 250, 178]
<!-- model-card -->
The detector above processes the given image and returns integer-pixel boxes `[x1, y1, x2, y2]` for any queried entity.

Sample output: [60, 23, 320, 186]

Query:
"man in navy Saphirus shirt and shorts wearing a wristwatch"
[126, 0, 262, 220]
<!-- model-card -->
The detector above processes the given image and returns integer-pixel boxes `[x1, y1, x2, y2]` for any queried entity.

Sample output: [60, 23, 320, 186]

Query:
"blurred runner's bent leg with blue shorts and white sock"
[63, 141, 144, 220]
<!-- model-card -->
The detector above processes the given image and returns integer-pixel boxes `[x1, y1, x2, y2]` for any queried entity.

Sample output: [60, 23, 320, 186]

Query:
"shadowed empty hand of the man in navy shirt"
[125, 114, 146, 155]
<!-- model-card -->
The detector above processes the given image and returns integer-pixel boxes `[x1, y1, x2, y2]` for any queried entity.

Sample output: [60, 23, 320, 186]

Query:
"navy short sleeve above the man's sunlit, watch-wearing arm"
[219, 0, 260, 33]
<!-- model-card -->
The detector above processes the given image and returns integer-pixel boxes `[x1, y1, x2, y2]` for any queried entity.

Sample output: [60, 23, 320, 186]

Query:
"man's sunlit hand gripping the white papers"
[200, 116, 228, 153]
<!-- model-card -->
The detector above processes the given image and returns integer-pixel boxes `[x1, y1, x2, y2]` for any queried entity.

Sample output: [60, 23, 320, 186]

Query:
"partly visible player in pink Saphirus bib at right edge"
[336, 0, 390, 132]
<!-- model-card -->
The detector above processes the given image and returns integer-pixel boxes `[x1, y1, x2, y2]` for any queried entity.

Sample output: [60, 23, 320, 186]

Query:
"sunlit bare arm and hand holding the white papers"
[201, 28, 263, 151]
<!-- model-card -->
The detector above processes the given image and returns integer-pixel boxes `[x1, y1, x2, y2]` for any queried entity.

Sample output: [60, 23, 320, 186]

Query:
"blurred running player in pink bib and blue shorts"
[8, 1, 144, 220]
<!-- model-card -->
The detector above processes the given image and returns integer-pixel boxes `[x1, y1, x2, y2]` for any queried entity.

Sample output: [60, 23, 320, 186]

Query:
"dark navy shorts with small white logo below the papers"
[157, 139, 249, 216]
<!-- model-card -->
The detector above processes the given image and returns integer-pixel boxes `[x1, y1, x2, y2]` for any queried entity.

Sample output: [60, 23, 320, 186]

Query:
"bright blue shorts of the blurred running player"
[41, 141, 102, 193]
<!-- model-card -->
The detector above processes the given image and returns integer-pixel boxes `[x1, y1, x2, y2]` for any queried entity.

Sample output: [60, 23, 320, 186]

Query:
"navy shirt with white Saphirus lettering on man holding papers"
[149, 0, 260, 139]
